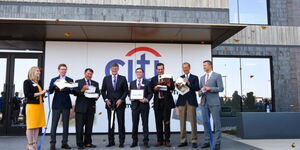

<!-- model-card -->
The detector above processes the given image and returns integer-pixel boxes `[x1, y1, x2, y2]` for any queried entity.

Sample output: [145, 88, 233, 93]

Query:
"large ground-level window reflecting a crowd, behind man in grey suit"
[213, 57, 272, 117]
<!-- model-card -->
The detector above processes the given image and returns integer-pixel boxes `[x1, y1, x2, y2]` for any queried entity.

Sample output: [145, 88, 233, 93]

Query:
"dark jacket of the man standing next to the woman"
[49, 76, 74, 109]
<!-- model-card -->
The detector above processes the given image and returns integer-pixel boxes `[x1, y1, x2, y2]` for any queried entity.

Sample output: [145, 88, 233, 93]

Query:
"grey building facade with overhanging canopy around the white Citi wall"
[0, 0, 300, 135]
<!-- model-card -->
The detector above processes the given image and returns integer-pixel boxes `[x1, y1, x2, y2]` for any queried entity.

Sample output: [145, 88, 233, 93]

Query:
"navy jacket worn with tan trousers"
[176, 74, 200, 107]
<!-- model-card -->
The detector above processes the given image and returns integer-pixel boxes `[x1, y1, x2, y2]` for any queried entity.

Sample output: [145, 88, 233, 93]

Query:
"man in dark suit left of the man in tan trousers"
[150, 63, 175, 147]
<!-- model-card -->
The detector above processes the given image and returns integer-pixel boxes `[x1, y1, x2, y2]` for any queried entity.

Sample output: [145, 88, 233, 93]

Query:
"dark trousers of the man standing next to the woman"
[50, 109, 70, 144]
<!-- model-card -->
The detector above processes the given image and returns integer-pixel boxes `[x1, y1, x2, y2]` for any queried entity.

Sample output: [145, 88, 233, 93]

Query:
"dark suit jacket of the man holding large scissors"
[101, 75, 128, 108]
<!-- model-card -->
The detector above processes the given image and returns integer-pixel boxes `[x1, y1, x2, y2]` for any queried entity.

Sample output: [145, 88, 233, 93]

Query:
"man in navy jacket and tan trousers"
[176, 62, 199, 148]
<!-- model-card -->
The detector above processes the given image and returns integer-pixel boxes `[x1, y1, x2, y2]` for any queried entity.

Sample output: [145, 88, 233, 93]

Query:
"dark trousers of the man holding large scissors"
[107, 106, 125, 144]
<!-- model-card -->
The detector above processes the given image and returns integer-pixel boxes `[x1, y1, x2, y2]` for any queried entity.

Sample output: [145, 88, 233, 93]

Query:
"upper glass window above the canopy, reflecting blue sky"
[229, 0, 268, 24]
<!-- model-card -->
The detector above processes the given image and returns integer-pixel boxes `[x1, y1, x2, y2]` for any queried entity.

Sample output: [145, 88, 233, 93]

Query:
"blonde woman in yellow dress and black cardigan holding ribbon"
[23, 67, 47, 150]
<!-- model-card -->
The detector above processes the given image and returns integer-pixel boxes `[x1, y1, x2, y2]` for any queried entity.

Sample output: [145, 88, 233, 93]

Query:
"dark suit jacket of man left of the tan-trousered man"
[150, 75, 175, 110]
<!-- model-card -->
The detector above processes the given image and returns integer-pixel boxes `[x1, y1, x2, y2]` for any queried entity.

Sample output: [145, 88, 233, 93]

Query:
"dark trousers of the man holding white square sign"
[132, 107, 149, 143]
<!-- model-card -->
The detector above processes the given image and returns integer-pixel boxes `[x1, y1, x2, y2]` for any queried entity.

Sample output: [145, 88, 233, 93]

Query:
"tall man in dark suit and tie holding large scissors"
[101, 64, 128, 148]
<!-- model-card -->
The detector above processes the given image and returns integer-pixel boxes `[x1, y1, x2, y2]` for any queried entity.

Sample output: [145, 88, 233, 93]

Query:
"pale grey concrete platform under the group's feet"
[0, 134, 261, 150]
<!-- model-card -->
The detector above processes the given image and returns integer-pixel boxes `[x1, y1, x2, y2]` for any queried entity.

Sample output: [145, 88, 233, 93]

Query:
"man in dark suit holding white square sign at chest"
[129, 68, 152, 148]
